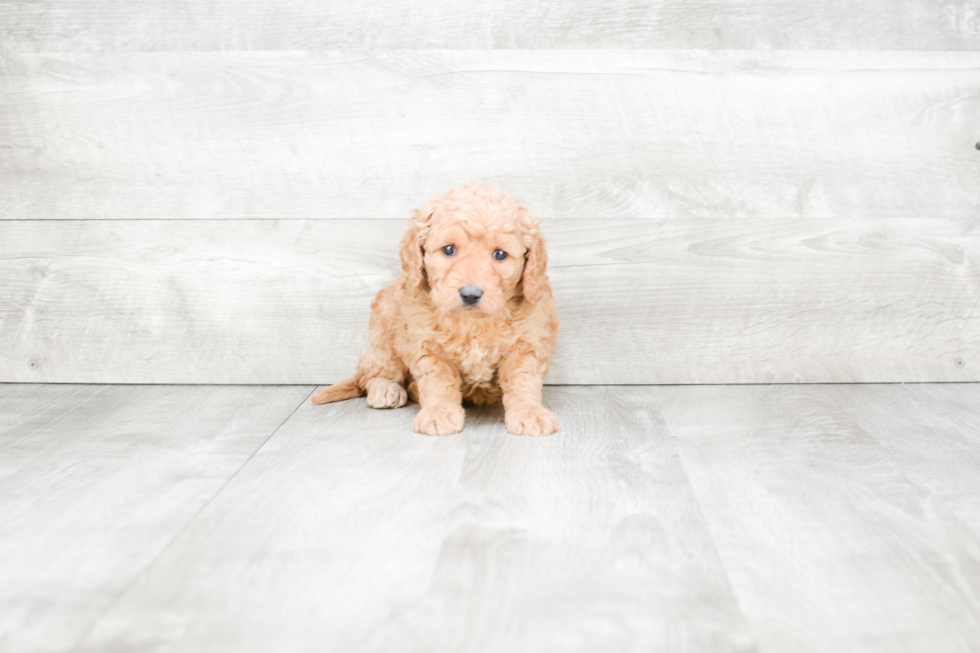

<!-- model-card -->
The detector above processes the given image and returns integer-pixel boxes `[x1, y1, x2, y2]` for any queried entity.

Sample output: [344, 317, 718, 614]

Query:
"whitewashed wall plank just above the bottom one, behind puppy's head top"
[0, 49, 980, 219]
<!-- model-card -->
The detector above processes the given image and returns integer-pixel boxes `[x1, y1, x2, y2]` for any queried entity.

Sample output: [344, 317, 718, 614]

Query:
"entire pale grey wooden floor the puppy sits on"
[0, 384, 980, 653]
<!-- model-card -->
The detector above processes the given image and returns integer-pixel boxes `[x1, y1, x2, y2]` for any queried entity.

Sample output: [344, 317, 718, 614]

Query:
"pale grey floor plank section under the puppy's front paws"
[78, 388, 752, 652]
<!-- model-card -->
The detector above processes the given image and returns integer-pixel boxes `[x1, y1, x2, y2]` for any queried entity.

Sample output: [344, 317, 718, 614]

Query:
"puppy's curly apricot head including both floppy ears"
[401, 184, 548, 316]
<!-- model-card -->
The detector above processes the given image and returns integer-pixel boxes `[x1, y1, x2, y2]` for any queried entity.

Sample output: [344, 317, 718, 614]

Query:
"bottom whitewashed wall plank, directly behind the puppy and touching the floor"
[0, 218, 980, 384]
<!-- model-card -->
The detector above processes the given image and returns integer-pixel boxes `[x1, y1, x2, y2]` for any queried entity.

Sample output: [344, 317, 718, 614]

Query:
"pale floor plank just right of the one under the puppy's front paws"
[650, 386, 980, 652]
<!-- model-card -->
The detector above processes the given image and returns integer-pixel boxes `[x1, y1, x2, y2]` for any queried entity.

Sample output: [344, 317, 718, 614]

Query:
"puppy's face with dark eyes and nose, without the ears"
[423, 220, 527, 316]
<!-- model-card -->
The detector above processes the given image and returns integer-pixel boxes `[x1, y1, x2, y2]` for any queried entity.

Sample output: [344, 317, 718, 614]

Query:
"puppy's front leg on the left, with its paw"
[411, 355, 465, 435]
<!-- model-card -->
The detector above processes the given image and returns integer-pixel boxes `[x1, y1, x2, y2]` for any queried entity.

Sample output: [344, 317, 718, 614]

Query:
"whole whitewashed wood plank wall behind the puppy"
[0, 0, 980, 384]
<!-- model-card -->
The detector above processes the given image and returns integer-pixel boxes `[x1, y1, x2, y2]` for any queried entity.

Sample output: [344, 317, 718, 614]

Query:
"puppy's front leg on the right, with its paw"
[497, 353, 558, 435]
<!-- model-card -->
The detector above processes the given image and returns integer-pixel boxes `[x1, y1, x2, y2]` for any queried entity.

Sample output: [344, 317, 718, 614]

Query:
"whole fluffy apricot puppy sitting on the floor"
[313, 184, 558, 435]
